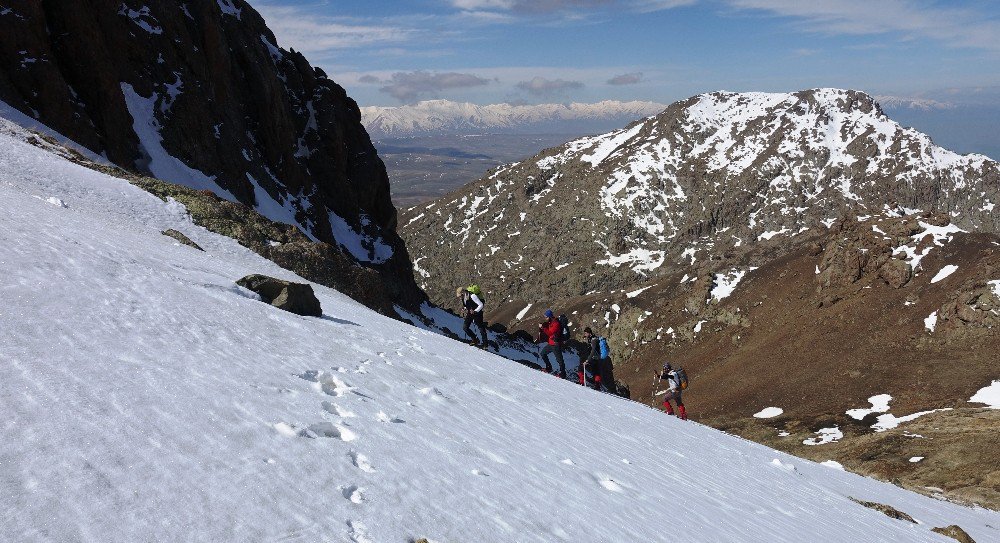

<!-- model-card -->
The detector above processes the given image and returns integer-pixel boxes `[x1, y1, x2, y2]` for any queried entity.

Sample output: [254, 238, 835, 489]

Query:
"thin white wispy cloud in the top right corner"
[726, 0, 1000, 51]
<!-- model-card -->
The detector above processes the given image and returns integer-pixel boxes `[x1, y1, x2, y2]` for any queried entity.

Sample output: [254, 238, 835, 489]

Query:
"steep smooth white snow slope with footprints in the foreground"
[0, 120, 1000, 543]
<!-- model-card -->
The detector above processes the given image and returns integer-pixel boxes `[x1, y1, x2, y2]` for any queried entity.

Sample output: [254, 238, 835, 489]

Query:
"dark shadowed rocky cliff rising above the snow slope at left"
[0, 0, 416, 310]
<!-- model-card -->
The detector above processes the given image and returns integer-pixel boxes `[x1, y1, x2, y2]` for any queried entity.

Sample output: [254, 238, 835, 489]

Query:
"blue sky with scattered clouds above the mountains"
[249, 0, 1000, 105]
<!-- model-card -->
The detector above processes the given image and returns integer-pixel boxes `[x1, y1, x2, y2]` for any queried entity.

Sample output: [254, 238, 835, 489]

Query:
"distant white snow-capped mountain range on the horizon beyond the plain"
[361, 100, 667, 139]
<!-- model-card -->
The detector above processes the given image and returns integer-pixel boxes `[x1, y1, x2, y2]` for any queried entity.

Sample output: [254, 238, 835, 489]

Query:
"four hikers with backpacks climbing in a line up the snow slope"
[455, 285, 688, 420]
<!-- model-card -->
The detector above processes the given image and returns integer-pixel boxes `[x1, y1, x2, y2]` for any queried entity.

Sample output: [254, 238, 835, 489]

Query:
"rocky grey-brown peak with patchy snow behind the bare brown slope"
[401, 89, 1000, 308]
